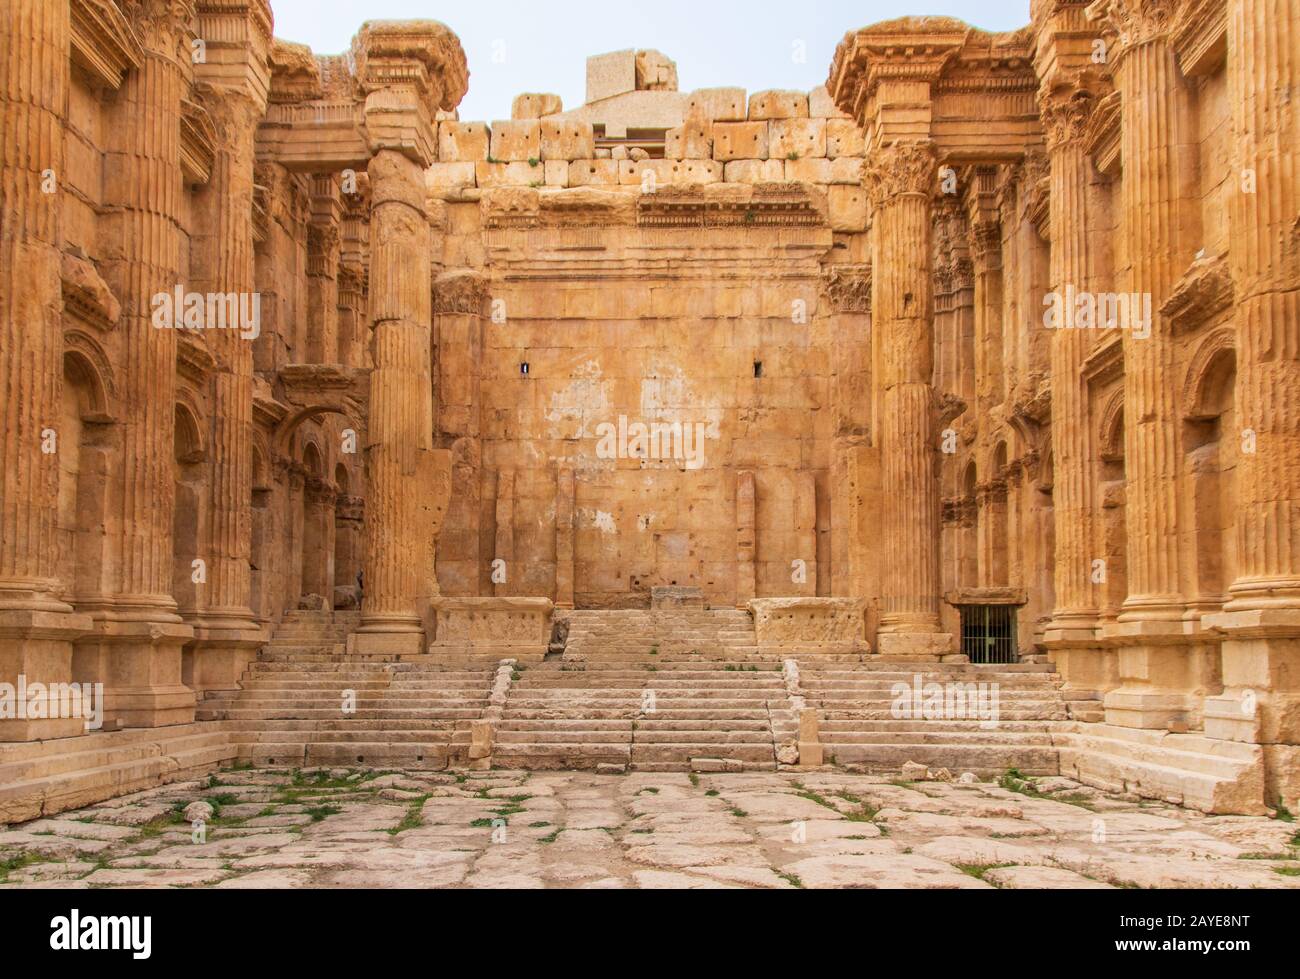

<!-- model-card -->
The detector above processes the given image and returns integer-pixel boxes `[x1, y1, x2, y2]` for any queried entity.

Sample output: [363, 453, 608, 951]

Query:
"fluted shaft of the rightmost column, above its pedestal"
[1227, 0, 1300, 608]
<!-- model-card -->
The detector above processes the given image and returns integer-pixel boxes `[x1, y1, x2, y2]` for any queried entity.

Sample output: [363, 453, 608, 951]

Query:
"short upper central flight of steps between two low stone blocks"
[564, 608, 758, 663]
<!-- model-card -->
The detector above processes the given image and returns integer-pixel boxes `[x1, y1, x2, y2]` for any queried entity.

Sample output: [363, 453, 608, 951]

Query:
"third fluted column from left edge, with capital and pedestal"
[185, 0, 272, 693]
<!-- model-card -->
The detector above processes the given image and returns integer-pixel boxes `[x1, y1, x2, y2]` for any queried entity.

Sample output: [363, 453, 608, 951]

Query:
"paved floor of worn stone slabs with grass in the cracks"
[0, 770, 1300, 888]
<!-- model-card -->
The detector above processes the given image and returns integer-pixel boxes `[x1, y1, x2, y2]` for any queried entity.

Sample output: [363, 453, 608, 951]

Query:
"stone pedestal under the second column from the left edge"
[73, 611, 195, 731]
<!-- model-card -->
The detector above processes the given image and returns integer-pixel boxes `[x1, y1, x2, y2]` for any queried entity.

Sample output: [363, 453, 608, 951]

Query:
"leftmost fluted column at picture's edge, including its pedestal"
[0, 0, 90, 741]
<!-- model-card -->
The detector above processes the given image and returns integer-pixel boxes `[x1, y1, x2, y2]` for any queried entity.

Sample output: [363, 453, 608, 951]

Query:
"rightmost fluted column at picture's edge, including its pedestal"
[1205, 0, 1300, 802]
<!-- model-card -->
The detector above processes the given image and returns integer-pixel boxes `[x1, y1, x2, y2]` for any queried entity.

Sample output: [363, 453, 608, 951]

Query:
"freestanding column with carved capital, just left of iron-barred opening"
[865, 140, 952, 659]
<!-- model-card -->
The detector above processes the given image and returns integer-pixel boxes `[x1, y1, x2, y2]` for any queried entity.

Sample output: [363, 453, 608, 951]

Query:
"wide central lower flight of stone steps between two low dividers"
[493, 654, 794, 771]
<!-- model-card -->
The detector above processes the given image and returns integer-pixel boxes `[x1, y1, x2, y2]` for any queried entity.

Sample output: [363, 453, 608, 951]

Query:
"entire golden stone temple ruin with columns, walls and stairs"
[0, 0, 1300, 822]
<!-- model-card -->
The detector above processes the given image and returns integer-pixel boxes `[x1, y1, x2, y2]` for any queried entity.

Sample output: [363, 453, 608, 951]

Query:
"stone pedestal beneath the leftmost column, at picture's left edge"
[0, 608, 94, 741]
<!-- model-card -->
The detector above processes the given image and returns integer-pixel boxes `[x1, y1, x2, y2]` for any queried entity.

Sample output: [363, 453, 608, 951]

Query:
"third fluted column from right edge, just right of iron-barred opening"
[1028, 78, 1113, 690]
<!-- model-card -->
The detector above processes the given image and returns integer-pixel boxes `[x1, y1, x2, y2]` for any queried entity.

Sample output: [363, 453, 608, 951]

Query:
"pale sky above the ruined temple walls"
[272, 0, 1030, 120]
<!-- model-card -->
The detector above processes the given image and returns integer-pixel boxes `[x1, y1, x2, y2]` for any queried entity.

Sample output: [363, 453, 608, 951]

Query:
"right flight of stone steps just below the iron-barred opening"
[801, 660, 1069, 775]
